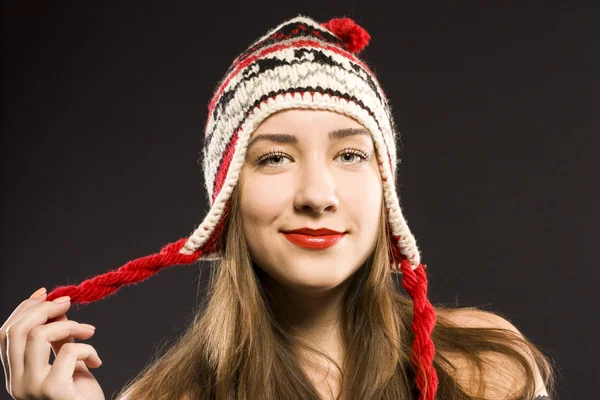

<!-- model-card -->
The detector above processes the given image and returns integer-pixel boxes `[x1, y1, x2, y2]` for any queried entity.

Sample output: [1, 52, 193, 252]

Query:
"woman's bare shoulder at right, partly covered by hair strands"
[440, 308, 547, 399]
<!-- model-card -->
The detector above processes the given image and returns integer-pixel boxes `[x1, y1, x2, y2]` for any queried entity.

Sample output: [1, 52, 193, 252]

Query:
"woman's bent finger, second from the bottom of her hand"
[23, 321, 94, 376]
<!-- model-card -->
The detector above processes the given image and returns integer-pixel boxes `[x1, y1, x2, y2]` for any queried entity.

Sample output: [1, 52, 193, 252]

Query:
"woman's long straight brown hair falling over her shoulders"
[117, 185, 554, 400]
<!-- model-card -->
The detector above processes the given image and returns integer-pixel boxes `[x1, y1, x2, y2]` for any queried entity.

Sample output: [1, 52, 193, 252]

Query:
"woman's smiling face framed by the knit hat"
[240, 109, 382, 291]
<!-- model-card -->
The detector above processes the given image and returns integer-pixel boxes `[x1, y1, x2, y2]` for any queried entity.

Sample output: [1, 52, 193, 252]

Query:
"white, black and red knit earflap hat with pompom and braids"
[48, 16, 438, 400]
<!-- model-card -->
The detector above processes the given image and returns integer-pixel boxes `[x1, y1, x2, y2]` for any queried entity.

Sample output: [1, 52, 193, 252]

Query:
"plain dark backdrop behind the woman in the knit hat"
[0, 1, 600, 399]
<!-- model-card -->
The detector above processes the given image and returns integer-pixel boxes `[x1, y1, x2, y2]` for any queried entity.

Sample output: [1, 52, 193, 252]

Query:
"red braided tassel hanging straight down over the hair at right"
[400, 259, 438, 400]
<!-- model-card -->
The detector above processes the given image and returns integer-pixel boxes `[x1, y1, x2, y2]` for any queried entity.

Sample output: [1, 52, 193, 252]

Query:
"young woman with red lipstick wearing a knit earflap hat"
[0, 16, 553, 400]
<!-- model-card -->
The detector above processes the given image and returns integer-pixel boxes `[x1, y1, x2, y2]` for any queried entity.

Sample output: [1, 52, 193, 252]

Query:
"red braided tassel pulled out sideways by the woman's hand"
[47, 238, 202, 304]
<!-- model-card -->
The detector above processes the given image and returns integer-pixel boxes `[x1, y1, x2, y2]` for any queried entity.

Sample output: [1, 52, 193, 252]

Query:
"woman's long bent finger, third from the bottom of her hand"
[6, 299, 71, 379]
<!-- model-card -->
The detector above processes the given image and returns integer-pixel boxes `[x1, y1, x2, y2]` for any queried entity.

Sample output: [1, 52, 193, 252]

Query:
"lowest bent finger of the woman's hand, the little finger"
[46, 343, 102, 383]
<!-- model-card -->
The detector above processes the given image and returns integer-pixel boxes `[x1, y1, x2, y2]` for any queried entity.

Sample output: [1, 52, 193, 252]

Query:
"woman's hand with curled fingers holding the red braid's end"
[0, 290, 104, 400]
